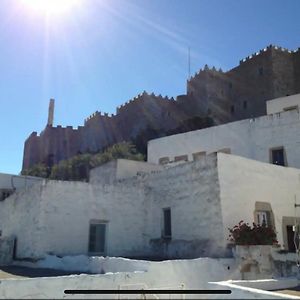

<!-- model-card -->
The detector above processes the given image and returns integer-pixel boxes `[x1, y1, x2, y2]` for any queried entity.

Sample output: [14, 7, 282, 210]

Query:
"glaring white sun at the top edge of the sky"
[23, 0, 80, 14]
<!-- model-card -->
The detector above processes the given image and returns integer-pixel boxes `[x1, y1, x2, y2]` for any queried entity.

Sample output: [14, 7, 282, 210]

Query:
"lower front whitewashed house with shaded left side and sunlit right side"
[0, 153, 300, 258]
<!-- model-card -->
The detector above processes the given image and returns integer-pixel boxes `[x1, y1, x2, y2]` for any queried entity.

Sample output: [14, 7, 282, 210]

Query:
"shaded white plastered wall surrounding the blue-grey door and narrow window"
[0, 155, 222, 257]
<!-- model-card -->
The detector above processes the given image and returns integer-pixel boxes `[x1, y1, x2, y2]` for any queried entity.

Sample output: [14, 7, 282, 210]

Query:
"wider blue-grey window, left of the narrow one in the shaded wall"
[89, 223, 107, 254]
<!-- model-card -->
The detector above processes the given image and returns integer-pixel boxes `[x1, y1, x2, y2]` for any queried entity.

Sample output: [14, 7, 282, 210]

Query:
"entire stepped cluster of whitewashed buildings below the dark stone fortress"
[0, 97, 300, 259]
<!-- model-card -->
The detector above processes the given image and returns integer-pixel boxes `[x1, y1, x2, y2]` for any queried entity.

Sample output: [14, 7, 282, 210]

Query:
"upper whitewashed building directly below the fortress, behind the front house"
[148, 94, 300, 168]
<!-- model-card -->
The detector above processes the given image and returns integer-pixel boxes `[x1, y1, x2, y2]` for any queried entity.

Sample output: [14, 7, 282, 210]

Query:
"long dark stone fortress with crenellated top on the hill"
[23, 45, 300, 169]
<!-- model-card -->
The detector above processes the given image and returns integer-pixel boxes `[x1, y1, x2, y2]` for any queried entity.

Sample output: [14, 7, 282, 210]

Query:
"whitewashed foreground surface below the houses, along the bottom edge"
[0, 255, 300, 299]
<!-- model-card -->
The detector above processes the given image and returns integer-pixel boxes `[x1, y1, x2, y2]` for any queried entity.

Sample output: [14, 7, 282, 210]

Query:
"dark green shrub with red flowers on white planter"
[228, 221, 278, 245]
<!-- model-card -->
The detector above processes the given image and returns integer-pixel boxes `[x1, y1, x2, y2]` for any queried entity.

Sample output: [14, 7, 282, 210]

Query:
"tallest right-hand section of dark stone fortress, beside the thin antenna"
[182, 45, 300, 124]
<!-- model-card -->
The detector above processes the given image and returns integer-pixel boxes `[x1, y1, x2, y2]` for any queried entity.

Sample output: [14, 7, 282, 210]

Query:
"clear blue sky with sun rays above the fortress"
[0, 0, 300, 173]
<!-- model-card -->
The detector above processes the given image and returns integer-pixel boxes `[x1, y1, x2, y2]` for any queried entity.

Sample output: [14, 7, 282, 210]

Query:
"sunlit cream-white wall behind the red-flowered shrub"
[218, 153, 300, 247]
